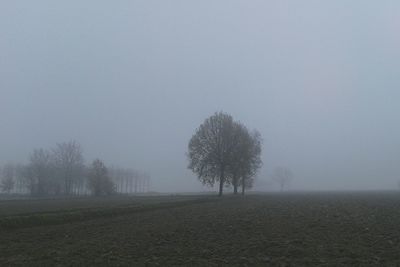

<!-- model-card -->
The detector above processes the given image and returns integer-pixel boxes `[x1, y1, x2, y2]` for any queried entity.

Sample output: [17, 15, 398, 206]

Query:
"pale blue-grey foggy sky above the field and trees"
[0, 0, 400, 192]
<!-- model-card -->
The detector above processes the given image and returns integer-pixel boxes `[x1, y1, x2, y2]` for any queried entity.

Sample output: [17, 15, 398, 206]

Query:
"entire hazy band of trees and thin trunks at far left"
[0, 141, 150, 196]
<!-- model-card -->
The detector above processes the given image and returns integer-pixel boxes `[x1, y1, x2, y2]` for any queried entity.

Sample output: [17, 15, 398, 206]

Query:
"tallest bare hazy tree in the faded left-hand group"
[53, 141, 84, 195]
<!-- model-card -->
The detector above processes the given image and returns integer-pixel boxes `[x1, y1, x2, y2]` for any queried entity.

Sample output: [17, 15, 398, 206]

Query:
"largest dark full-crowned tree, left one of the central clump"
[187, 112, 235, 196]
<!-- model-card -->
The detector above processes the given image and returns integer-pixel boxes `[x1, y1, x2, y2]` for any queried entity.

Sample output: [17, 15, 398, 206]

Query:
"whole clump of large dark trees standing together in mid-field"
[187, 112, 262, 196]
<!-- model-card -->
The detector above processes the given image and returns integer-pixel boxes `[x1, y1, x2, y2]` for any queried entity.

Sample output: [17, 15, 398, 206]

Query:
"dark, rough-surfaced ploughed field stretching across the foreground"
[0, 192, 400, 266]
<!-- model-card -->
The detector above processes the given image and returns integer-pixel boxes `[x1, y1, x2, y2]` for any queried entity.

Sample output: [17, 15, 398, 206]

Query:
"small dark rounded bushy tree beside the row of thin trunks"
[88, 159, 115, 196]
